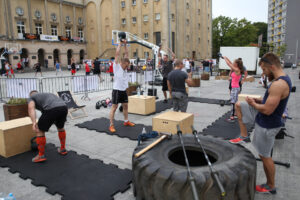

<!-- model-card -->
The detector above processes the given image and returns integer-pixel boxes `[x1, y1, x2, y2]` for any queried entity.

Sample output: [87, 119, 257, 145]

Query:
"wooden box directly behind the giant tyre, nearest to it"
[152, 111, 194, 134]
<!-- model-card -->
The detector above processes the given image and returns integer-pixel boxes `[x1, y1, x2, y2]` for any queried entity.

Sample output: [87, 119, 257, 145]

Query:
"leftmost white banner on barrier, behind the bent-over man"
[6, 79, 37, 98]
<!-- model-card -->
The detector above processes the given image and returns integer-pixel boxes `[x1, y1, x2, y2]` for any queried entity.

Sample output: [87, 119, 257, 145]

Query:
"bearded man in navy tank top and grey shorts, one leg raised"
[230, 53, 292, 194]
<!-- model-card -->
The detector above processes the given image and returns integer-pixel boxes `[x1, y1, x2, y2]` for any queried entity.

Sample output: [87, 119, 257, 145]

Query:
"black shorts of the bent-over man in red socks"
[38, 106, 68, 132]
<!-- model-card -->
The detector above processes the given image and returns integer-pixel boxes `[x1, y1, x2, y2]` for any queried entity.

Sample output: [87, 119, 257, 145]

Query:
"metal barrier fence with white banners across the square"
[0, 72, 145, 101]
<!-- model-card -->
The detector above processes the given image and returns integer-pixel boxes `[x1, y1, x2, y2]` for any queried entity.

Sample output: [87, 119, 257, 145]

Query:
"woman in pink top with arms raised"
[223, 56, 243, 122]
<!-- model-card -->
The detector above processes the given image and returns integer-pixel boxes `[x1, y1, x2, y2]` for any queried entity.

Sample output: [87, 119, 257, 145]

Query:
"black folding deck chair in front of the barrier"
[57, 90, 87, 119]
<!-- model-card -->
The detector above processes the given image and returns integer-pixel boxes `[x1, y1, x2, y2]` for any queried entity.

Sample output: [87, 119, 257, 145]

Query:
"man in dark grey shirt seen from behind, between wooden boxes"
[168, 60, 193, 112]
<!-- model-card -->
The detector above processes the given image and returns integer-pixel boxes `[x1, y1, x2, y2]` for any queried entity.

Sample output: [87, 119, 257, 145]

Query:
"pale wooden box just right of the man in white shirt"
[128, 95, 156, 115]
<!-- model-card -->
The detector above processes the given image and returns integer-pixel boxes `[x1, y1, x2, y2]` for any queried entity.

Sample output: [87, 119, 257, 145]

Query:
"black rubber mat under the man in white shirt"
[75, 117, 152, 140]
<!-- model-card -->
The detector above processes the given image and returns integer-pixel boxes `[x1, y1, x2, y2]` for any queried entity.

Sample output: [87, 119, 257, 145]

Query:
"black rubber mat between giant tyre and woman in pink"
[200, 111, 254, 139]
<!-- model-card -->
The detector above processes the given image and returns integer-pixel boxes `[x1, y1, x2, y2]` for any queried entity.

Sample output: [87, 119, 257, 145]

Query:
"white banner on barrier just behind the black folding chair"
[72, 76, 99, 93]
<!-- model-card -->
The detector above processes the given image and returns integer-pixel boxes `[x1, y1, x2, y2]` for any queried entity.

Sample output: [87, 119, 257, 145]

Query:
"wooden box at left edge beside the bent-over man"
[0, 117, 35, 158]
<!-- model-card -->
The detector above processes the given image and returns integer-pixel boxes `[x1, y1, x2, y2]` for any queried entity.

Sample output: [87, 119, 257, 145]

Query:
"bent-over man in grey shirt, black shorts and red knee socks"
[28, 90, 68, 162]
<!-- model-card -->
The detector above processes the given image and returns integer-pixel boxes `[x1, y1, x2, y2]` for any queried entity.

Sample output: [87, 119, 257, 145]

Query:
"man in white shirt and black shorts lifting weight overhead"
[109, 38, 135, 133]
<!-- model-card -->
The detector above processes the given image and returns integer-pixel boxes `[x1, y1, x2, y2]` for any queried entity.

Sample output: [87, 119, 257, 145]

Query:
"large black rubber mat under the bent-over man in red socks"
[0, 144, 132, 200]
